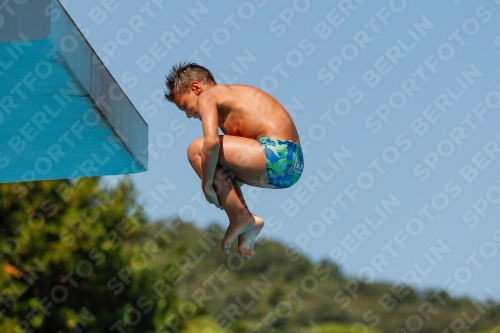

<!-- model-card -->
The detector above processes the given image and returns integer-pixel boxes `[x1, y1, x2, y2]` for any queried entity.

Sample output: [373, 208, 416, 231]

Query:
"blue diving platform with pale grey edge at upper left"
[0, 0, 148, 182]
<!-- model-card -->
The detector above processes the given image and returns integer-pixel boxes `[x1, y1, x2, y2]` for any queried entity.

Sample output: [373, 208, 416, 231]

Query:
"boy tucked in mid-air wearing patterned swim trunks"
[165, 63, 304, 260]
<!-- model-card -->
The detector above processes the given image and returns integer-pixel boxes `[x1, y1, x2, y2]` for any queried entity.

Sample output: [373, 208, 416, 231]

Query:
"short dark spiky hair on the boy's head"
[165, 62, 216, 102]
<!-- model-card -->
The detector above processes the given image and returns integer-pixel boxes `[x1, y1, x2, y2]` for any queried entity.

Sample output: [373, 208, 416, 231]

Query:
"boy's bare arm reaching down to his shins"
[198, 92, 220, 208]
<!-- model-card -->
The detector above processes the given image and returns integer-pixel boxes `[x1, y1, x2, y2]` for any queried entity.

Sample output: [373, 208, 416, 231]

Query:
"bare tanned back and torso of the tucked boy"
[200, 84, 300, 144]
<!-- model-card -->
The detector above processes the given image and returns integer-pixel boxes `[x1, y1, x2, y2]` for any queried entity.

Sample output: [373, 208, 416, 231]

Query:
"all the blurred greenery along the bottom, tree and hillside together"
[0, 177, 500, 333]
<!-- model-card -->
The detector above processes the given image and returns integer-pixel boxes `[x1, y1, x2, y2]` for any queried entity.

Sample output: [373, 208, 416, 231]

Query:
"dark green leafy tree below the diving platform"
[0, 177, 177, 333]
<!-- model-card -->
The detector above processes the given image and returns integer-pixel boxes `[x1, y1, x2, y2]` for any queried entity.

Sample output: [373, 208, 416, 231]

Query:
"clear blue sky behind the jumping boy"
[65, 0, 500, 299]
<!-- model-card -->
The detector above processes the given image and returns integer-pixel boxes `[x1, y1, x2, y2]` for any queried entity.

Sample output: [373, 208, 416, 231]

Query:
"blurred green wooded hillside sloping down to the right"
[148, 221, 500, 333]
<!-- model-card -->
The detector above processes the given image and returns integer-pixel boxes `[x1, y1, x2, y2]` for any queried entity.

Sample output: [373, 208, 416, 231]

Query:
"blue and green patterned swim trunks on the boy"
[257, 136, 304, 188]
